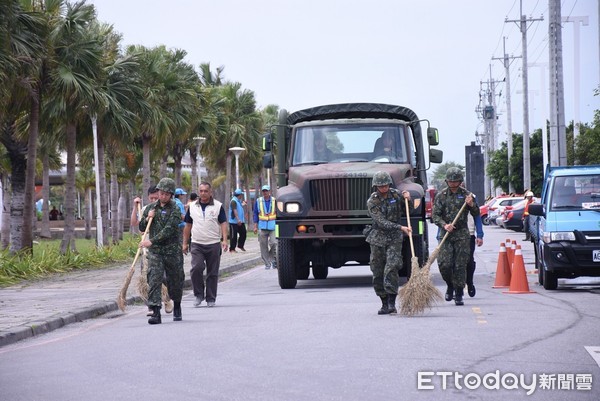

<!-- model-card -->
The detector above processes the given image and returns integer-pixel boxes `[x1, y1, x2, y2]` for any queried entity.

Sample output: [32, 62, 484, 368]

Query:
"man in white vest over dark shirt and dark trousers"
[182, 182, 228, 307]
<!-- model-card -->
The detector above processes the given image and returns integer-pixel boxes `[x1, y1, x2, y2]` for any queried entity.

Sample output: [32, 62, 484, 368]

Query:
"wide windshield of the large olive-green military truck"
[292, 124, 409, 166]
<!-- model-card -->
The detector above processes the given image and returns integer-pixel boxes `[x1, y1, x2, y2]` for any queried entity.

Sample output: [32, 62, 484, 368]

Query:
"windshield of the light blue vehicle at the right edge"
[550, 175, 600, 210]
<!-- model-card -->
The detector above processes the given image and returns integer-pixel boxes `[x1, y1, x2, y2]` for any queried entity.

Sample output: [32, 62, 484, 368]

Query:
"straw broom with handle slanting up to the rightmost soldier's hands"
[398, 202, 467, 316]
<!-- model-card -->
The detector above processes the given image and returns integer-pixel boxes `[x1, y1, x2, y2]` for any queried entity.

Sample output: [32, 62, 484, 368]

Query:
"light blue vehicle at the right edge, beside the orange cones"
[529, 166, 600, 290]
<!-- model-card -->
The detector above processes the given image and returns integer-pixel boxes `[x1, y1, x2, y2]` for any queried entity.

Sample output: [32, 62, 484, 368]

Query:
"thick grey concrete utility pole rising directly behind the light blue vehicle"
[548, 0, 567, 166]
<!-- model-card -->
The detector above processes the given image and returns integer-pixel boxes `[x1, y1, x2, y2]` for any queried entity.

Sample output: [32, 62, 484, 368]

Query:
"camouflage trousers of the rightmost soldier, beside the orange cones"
[438, 236, 471, 288]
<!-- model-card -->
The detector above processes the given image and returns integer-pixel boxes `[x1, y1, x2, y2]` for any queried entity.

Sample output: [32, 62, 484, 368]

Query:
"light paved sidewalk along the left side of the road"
[0, 237, 262, 347]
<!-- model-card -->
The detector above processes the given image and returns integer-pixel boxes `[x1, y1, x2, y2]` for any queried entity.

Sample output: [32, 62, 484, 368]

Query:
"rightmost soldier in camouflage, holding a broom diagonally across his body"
[431, 167, 479, 305]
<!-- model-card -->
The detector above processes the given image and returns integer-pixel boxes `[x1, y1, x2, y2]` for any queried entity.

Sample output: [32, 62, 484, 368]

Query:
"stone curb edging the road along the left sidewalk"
[0, 257, 262, 347]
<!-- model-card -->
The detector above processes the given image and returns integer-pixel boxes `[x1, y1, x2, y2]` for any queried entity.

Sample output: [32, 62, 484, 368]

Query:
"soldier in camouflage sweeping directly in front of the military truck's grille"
[366, 171, 412, 315]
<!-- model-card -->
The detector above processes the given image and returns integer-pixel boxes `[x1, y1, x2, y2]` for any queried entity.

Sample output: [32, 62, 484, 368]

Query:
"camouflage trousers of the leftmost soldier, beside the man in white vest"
[148, 252, 185, 306]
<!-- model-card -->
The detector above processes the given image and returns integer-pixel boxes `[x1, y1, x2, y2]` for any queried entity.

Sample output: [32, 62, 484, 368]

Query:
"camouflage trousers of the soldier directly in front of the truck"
[369, 241, 402, 297]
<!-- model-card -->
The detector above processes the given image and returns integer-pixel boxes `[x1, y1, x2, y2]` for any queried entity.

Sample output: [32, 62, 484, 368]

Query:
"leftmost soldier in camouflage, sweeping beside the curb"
[140, 178, 185, 324]
